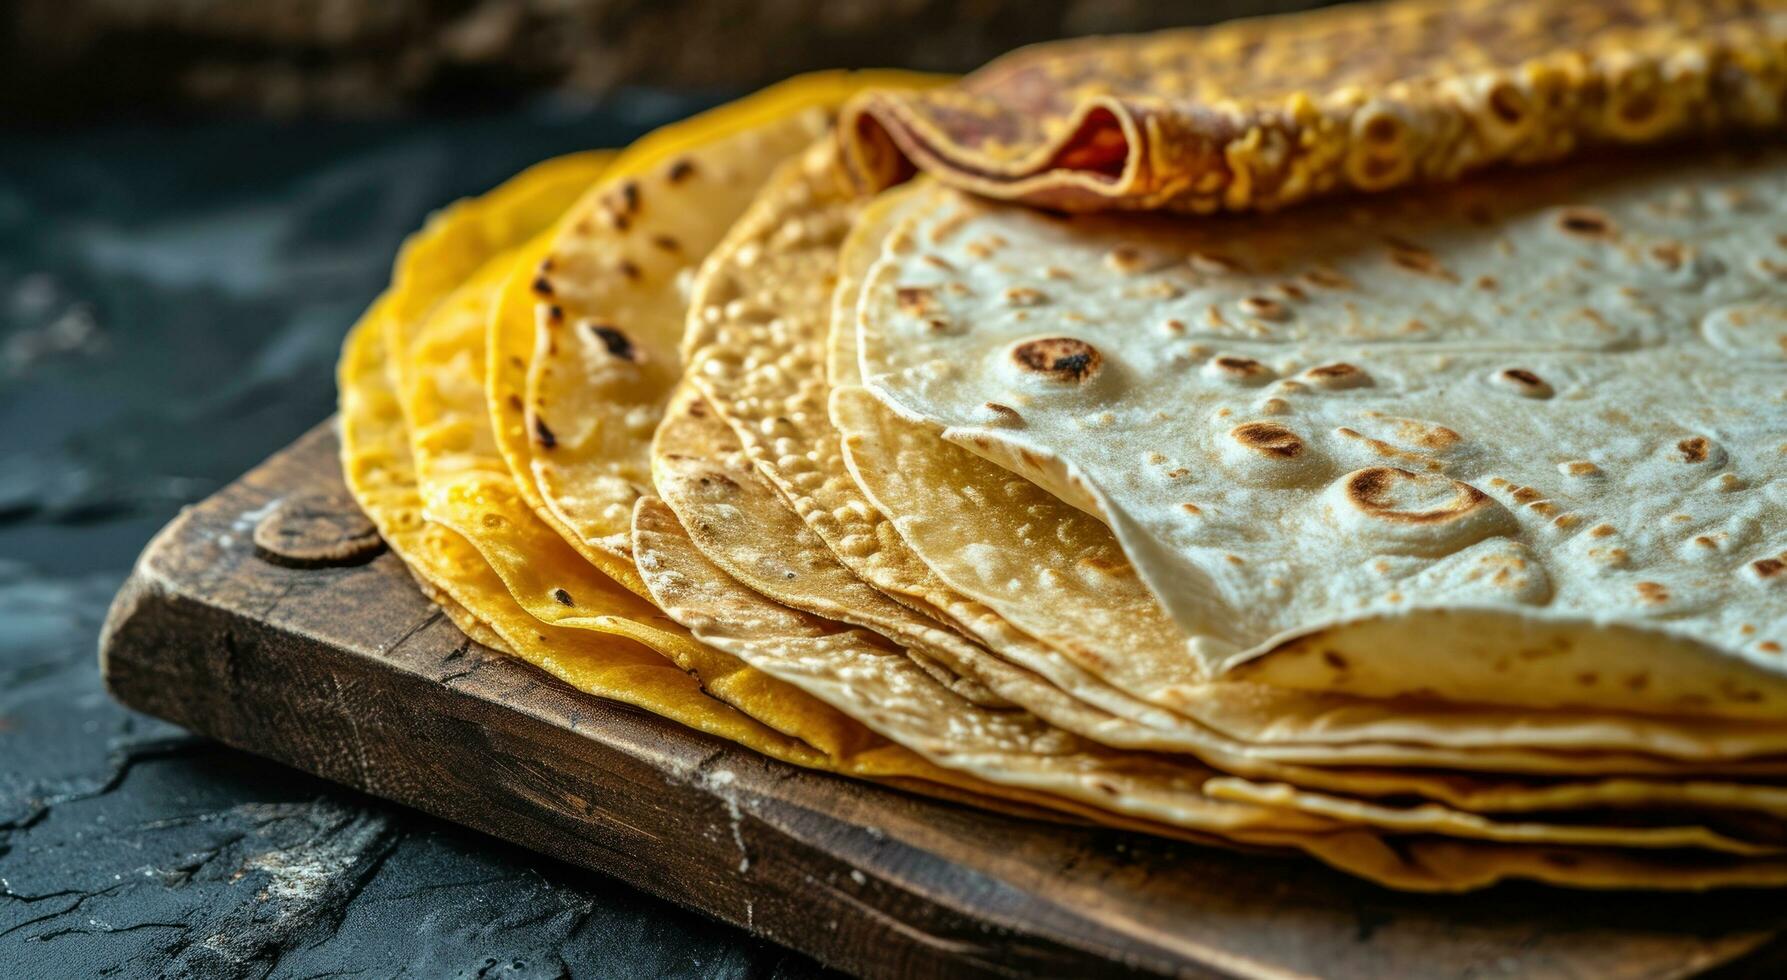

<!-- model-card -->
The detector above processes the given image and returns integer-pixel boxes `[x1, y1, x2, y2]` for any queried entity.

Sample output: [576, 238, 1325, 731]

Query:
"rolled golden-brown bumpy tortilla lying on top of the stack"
[842, 0, 1787, 213]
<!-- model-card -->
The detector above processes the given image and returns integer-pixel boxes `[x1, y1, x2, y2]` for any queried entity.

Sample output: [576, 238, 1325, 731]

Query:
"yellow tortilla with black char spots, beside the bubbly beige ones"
[486, 72, 935, 594]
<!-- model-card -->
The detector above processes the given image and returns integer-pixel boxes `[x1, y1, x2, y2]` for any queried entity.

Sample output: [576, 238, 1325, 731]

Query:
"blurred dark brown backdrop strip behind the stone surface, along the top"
[0, 0, 1321, 122]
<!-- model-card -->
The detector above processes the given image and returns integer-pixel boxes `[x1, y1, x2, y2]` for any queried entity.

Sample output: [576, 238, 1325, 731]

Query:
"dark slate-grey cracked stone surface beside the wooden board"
[0, 97, 818, 978]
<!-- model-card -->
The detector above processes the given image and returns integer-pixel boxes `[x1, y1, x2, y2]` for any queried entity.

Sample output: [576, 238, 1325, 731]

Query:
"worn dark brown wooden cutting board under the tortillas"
[100, 424, 1787, 978]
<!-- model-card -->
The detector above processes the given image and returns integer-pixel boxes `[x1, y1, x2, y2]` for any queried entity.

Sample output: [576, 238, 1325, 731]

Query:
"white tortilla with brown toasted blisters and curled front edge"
[858, 154, 1787, 722]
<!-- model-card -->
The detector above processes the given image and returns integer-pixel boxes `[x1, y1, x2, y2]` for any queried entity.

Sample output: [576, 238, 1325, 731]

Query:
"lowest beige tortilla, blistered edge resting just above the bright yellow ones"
[633, 497, 1787, 891]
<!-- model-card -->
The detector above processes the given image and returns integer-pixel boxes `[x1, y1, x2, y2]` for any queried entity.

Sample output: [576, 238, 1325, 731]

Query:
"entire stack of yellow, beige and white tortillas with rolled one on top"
[341, 0, 1787, 891]
